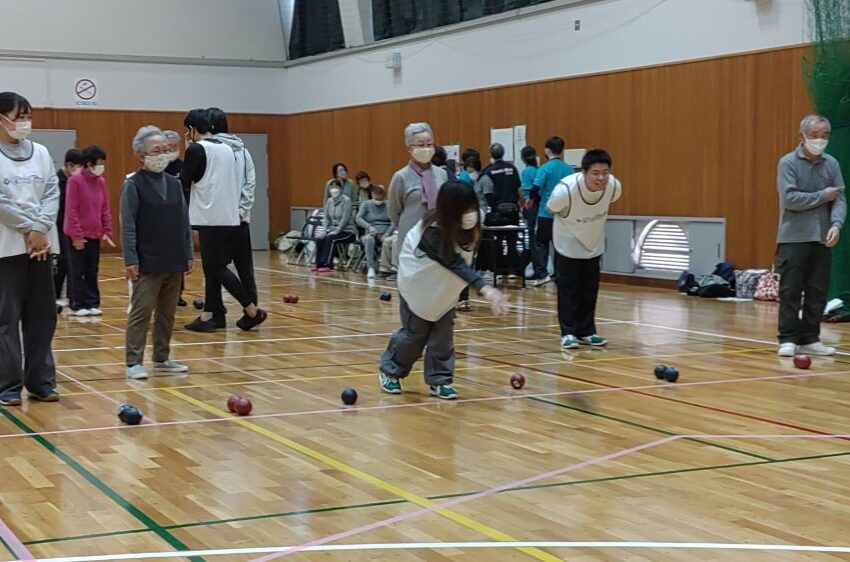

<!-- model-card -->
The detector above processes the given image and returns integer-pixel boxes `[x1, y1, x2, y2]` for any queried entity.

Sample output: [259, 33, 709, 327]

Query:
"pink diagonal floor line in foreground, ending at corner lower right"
[250, 435, 679, 562]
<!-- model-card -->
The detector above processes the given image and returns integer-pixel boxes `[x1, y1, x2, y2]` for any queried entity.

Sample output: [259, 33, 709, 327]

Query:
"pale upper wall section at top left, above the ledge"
[0, 0, 285, 61]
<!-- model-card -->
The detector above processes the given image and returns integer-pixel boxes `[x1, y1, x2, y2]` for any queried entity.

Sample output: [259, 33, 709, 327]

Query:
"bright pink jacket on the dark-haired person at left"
[62, 169, 112, 240]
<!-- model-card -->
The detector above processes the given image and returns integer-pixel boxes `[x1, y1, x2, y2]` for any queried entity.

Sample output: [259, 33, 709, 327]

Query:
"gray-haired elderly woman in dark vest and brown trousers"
[121, 125, 194, 379]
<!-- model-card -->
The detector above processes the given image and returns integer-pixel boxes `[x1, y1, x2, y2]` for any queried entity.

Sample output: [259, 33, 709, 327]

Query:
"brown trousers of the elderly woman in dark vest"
[127, 273, 183, 367]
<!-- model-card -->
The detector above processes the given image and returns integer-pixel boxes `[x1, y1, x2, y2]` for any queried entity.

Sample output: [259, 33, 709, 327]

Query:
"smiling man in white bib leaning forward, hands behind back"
[547, 149, 622, 349]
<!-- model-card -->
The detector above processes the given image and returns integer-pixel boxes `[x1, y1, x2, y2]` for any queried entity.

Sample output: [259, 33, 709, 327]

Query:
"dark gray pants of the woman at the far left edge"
[0, 254, 56, 394]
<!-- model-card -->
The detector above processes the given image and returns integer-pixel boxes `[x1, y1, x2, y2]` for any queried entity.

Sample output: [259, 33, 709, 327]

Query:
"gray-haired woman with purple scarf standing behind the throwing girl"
[387, 123, 448, 264]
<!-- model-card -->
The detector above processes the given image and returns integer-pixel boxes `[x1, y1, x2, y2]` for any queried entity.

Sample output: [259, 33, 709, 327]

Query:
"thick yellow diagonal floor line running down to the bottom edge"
[167, 389, 561, 562]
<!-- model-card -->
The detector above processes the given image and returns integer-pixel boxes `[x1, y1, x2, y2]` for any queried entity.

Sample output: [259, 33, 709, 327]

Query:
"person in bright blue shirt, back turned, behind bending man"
[529, 137, 575, 287]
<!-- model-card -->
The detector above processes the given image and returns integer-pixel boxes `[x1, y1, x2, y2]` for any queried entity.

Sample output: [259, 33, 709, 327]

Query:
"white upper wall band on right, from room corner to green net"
[280, 0, 807, 113]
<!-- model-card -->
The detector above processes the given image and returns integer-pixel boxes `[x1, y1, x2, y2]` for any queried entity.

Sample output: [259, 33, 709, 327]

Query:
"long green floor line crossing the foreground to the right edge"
[24, 451, 850, 546]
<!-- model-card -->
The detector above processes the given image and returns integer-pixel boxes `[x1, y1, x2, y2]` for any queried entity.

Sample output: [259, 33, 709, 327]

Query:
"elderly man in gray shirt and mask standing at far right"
[776, 115, 847, 357]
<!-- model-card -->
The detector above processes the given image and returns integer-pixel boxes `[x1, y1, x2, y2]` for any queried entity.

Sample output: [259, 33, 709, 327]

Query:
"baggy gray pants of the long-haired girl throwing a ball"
[381, 298, 455, 385]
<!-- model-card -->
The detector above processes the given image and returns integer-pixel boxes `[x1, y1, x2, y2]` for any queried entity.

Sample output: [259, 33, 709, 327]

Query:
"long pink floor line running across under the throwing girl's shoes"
[0, 371, 850, 439]
